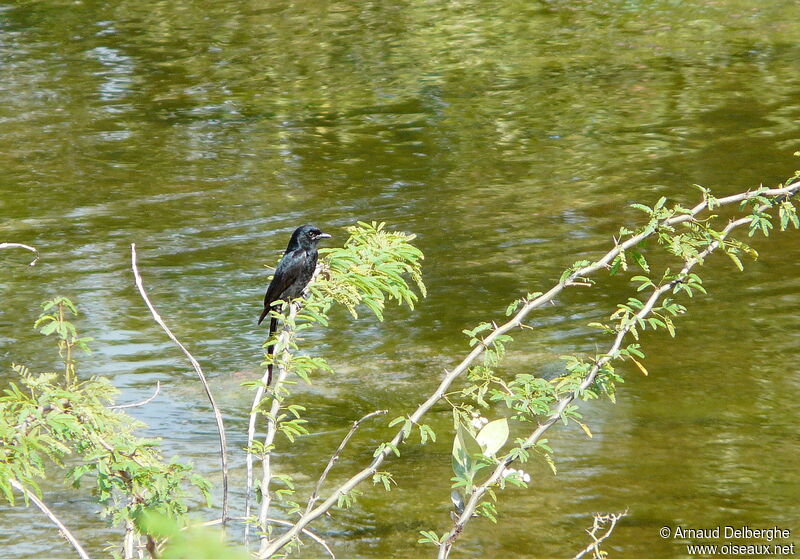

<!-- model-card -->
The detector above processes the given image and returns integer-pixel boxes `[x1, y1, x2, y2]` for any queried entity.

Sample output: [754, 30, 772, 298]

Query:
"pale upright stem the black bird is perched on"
[257, 300, 301, 552]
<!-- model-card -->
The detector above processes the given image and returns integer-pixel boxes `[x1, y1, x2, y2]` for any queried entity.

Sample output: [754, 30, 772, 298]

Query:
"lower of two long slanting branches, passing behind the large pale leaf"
[438, 209, 770, 559]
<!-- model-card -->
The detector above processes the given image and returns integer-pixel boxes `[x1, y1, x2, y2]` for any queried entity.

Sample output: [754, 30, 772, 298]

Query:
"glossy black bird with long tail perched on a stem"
[258, 225, 331, 386]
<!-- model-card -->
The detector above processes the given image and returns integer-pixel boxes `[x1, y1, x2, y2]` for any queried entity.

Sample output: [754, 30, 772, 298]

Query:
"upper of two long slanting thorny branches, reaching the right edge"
[259, 182, 800, 557]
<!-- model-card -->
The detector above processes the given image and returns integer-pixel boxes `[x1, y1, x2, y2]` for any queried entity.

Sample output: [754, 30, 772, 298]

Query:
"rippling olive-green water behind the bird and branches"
[0, 0, 800, 559]
